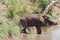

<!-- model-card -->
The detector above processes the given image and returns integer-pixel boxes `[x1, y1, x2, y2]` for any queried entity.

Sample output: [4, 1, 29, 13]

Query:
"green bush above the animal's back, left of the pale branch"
[33, 0, 50, 14]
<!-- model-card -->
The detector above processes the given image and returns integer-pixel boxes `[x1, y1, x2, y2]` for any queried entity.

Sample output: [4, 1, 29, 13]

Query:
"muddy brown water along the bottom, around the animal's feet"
[9, 25, 60, 40]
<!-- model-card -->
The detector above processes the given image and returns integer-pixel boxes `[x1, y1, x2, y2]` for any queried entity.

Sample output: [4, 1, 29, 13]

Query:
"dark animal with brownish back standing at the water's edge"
[19, 14, 57, 34]
